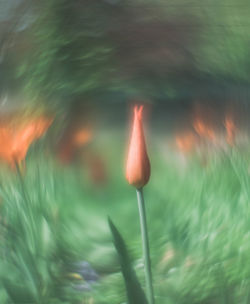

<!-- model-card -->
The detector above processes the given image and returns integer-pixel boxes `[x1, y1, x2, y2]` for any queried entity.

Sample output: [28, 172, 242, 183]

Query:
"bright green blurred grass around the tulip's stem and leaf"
[0, 134, 250, 304]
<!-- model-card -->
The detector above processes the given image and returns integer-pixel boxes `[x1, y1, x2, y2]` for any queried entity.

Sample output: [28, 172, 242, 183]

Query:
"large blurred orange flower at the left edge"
[0, 116, 52, 168]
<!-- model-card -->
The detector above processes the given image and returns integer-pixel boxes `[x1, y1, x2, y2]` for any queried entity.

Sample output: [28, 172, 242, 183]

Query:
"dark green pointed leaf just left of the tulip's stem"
[108, 218, 147, 304]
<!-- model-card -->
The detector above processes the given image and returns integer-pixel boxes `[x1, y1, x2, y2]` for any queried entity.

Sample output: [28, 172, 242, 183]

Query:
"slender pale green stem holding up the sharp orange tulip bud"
[136, 188, 154, 304]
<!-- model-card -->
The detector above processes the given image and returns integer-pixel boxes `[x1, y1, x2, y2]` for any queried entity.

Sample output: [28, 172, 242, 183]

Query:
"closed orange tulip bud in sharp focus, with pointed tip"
[126, 106, 150, 189]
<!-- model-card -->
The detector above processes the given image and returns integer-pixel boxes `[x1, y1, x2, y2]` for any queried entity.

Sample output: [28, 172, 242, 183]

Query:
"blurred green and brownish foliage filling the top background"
[8, 0, 250, 103]
